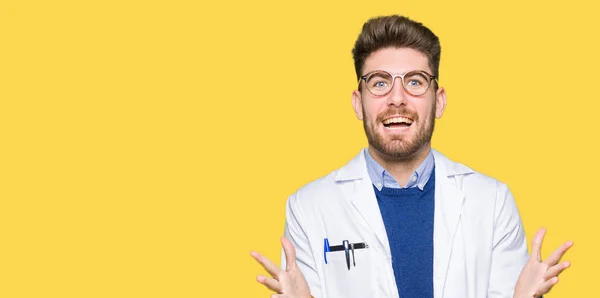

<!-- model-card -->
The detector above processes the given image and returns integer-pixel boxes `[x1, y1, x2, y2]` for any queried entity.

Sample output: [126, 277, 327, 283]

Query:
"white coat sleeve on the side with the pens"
[281, 194, 323, 298]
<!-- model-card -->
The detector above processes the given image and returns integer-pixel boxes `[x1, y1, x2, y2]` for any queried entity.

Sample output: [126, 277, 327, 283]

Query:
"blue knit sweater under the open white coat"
[373, 170, 435, 298]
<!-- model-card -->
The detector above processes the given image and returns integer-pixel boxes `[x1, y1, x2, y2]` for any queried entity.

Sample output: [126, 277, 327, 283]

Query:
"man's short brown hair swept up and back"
[352, 15, 442, 80]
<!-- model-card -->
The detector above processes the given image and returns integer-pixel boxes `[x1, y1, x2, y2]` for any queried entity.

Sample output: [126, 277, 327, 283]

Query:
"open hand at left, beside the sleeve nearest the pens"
[250, 237, 312, 298]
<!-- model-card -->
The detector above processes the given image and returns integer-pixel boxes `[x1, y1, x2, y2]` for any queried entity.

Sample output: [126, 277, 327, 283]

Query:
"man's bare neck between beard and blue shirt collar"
[369, 143, 431, 185]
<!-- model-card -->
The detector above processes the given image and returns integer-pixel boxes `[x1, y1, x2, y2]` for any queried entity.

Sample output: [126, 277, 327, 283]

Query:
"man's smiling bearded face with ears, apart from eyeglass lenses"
[352, 48, 446, 159]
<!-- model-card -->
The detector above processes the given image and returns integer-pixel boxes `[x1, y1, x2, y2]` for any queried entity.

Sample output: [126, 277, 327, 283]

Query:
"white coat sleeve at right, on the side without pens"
[487, 183, 528, 298]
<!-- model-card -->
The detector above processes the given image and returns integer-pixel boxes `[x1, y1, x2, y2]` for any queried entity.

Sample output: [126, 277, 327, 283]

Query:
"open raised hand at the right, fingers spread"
[514, 228, 573, 298]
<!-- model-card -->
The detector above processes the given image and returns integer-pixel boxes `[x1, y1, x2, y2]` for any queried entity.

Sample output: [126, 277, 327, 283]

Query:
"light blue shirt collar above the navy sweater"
[365, 150, 435, 190]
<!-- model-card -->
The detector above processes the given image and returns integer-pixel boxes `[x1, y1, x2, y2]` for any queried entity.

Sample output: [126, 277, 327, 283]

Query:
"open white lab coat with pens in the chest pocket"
[281, 149, 528, 298]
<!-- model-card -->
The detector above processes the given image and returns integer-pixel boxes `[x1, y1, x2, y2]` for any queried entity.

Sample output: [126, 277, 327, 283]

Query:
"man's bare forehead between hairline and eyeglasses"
[363, 48, 431, 74]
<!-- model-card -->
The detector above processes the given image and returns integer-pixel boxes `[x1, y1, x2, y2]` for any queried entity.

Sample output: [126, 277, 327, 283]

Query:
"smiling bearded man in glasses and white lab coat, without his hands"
[260, 16, 568, 298]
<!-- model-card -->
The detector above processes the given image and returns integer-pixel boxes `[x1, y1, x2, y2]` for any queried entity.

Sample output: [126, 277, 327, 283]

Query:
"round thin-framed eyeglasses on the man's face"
[358, 70, 437, 96]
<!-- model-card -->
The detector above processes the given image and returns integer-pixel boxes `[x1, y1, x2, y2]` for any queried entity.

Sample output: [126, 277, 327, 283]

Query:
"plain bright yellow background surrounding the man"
[0, 0, 600, 297]
